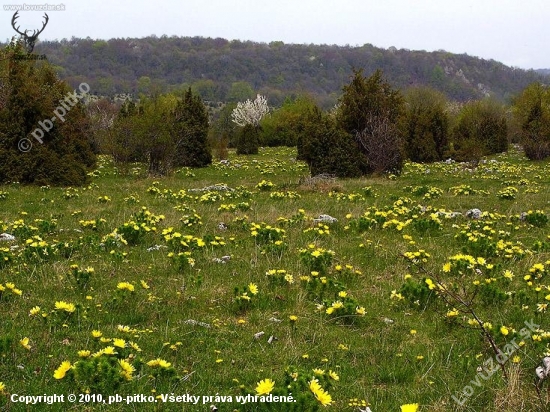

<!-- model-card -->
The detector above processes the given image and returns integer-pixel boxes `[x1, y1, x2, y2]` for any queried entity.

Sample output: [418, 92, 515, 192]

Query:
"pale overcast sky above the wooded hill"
[0, 0, 550, 69]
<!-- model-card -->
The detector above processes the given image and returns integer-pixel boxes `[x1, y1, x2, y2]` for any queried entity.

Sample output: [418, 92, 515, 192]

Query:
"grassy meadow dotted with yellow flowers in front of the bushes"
[0, 148, 550, 412]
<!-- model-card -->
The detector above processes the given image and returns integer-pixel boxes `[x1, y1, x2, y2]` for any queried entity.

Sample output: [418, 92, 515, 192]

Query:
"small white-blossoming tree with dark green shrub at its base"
[231, 94, 269, 154]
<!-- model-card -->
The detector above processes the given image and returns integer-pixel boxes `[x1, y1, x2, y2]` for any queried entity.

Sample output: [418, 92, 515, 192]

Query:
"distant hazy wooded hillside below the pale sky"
[19, 36, 549, 107]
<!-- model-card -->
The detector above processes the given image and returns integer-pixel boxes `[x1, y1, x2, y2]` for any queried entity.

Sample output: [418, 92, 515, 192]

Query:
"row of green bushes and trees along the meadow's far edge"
[0, 44, 550, 186]
